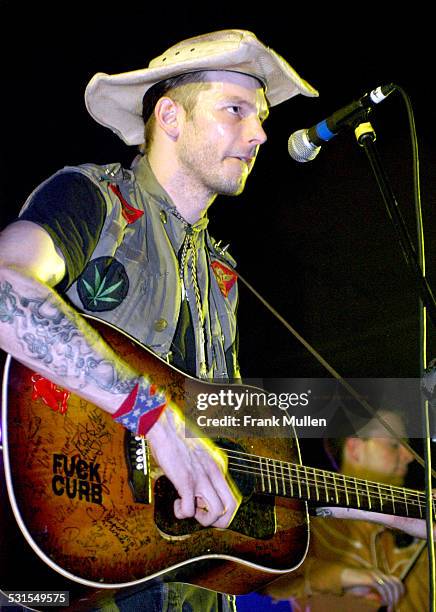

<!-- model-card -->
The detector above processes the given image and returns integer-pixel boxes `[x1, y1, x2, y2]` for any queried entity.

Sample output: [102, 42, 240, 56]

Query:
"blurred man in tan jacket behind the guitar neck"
[266, 411, 428, 612]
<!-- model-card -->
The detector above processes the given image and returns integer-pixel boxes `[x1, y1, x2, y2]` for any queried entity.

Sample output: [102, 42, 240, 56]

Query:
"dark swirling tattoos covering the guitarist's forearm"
[0, 281, 137, 394]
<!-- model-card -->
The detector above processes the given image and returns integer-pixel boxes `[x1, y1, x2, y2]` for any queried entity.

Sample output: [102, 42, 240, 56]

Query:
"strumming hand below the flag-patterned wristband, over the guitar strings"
[146, 404, 241, 528]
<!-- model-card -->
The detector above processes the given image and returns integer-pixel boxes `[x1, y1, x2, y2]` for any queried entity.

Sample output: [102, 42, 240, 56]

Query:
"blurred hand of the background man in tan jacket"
[341, 567, 404, 610]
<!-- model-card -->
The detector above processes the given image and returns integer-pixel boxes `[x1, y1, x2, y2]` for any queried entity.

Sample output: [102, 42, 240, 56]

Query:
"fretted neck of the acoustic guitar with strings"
[229, 452, 434, 518]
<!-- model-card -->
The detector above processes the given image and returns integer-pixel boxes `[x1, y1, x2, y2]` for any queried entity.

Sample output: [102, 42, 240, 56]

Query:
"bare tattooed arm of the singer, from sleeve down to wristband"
[0, 221, 138, 413]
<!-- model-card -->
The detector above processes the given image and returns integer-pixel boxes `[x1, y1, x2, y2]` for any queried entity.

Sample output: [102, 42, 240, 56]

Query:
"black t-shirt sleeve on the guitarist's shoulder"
[19, 172, 106, 291]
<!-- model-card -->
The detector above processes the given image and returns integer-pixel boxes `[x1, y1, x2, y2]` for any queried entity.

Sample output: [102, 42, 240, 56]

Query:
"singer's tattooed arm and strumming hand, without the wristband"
[0, 221, 239, 527]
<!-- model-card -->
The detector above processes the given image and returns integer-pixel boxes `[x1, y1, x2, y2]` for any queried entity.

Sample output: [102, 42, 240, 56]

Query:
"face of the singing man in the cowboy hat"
[177, 71, 268, 195]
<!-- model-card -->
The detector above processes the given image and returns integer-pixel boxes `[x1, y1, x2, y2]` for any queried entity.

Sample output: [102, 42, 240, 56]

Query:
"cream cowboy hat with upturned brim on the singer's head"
[85, 30, 318, 145]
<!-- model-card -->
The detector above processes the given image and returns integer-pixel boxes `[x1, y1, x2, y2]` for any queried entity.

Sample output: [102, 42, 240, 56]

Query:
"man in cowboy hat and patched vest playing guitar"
[0, 30, 317, 610]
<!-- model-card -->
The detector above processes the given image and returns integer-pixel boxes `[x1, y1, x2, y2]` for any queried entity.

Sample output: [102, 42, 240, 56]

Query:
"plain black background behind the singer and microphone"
[0, 2, 436, 608]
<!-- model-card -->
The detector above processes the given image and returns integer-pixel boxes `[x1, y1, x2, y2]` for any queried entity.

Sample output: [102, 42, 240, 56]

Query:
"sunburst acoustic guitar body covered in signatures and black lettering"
[3, 323, 308, 594]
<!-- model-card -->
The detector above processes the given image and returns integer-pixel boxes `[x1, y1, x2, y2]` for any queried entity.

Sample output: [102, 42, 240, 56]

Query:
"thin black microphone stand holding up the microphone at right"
[353, 116, 436, 612]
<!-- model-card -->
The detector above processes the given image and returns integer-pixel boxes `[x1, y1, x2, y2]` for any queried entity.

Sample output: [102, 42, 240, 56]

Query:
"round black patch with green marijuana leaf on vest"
[77, 257, 129, 312]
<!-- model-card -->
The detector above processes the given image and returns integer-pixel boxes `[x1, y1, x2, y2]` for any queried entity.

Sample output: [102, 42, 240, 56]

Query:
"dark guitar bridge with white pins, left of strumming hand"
[124, 430, 151, 504]
